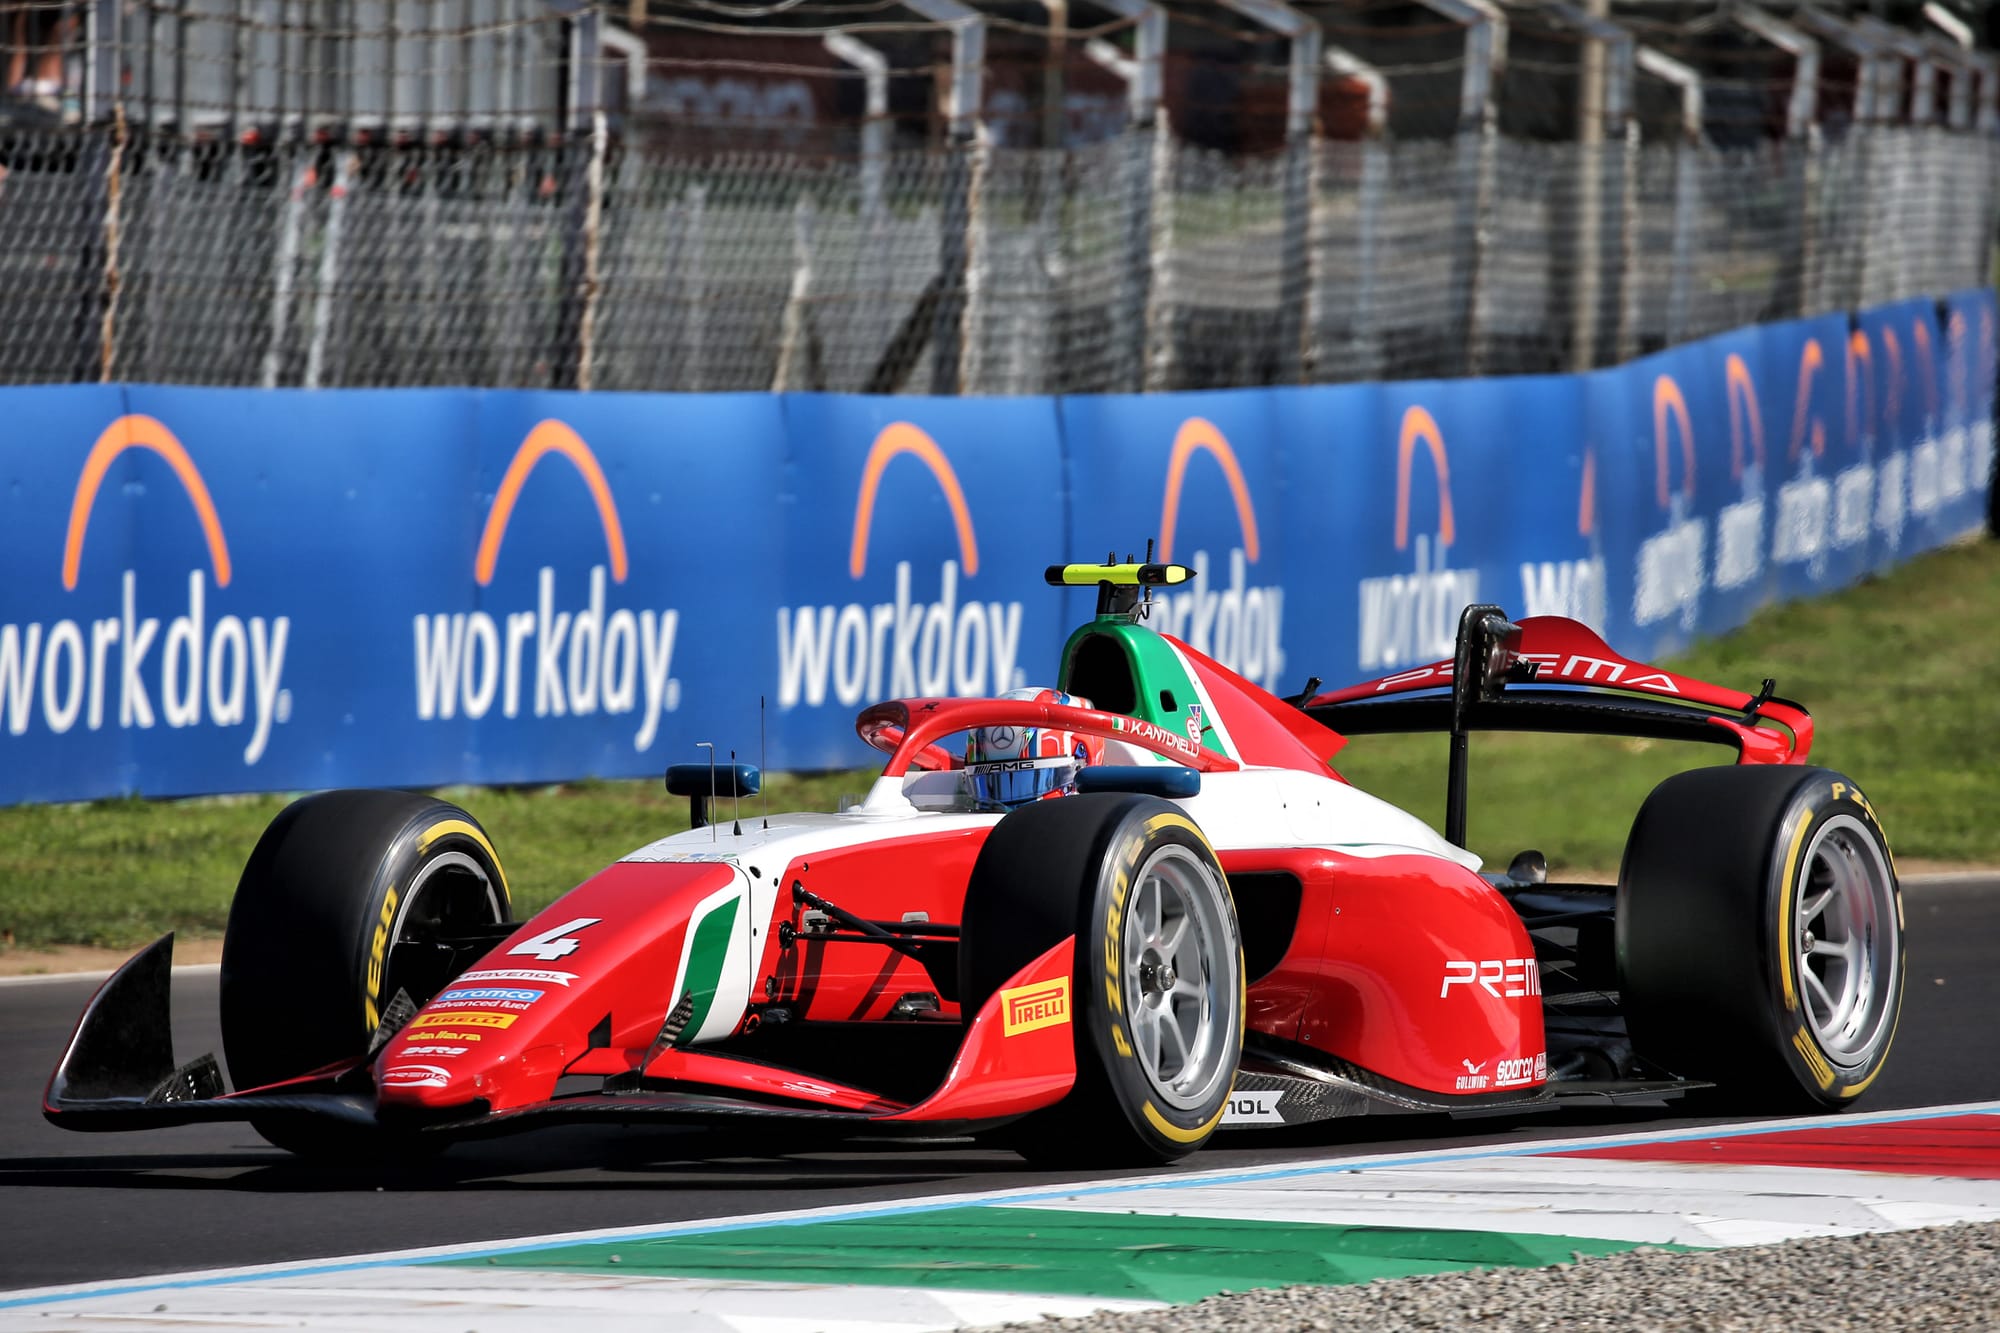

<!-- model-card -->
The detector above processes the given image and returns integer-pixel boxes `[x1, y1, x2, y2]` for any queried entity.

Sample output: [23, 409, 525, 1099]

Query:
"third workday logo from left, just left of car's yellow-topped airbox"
[778, 420, 1026, 709]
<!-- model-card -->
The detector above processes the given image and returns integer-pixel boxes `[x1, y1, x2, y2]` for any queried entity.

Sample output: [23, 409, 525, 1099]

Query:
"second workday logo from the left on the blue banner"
[416, 418, 680, 751]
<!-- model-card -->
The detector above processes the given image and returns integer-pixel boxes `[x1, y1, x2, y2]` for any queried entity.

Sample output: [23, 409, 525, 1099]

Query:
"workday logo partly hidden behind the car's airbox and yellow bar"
[1158, 416, 1284, 687]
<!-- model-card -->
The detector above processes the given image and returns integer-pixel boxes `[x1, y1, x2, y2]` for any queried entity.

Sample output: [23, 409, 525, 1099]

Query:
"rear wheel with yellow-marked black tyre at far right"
[1616, 765, 1906, 1111]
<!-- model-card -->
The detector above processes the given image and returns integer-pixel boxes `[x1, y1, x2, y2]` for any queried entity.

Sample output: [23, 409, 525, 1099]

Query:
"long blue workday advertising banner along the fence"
[0, 290, 2000, 803]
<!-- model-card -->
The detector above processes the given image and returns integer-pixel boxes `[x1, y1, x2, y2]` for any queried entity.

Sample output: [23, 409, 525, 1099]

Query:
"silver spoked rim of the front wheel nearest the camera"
[1122, 845, 1238, 1111]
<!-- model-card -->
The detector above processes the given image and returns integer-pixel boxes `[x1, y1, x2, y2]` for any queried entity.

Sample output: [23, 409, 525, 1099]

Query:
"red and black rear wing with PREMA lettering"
[1300, 604, 1812, 847]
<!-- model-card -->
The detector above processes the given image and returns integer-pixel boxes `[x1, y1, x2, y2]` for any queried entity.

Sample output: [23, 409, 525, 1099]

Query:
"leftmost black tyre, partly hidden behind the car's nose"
[222, 791, 512, 1157]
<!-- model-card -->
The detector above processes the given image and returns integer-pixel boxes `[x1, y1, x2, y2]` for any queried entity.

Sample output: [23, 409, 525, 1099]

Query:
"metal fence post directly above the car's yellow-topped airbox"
[1084, 0, 1166, 392]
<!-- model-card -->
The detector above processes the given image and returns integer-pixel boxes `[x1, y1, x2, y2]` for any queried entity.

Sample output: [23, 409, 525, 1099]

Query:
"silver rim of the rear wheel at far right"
[1792, 815, 1902, 1069]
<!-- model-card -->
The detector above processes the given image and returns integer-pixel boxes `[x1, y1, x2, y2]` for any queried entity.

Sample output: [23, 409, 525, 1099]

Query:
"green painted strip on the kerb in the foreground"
[442, 1207, 1672, 1301]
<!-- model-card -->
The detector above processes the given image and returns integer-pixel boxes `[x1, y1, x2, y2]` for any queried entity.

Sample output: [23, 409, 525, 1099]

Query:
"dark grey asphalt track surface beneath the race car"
[0, 877, 2000, 1291]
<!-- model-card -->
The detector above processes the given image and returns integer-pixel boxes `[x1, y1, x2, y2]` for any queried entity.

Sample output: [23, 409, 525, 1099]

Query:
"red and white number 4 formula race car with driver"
[44, 562, 1904, 1165]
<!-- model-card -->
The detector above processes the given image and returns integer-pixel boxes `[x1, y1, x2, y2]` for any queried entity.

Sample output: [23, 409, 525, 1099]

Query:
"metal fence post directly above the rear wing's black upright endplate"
[1418, 0, 1506, 374]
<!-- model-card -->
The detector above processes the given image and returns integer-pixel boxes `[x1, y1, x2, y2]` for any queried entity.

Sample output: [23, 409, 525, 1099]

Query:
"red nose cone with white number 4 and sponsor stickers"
[376, 861, 752, 1113]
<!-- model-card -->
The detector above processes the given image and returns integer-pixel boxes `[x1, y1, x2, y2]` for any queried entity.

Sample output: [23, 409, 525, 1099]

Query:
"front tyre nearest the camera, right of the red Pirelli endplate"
[958, 793, 1244, 1165]
